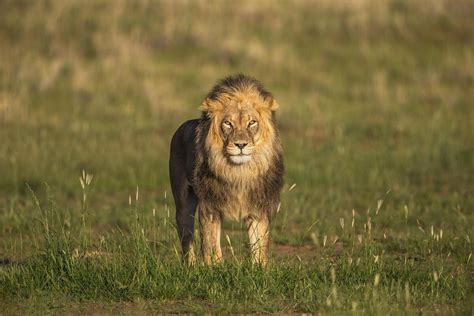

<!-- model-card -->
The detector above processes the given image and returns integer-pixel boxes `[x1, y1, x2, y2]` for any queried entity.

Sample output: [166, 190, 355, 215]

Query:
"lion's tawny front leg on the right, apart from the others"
[245, 215, 270, 266]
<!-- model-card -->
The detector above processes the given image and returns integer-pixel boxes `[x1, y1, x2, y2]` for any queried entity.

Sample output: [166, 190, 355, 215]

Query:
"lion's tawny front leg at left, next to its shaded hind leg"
[199, 207, 222, 265]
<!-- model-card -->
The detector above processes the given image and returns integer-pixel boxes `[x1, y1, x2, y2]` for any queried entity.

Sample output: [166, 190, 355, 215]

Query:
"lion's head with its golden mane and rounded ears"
[197, 75, 281, 180]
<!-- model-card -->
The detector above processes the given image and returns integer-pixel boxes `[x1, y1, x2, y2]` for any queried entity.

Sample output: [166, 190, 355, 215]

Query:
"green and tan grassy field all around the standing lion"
[0, 0, 474, 314]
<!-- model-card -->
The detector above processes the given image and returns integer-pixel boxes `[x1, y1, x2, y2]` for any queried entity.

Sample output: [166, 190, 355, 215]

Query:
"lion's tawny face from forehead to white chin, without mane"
[220, 105, 261, 165]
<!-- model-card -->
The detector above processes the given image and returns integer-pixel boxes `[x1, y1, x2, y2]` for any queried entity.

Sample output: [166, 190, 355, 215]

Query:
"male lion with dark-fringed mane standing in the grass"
[169, 75, 283, 265]
